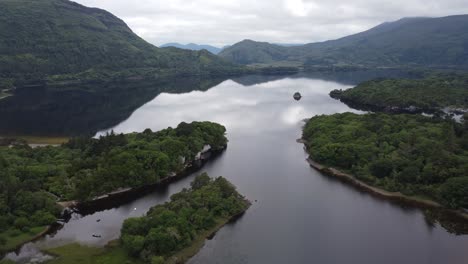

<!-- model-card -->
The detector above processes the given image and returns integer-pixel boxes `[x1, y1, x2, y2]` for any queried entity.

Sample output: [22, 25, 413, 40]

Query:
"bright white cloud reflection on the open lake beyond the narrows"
[98, 78, 362, 135]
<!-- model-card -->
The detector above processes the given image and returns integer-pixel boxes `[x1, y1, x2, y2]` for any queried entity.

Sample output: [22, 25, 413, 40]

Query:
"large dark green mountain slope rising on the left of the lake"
[0, 0, 240, 87]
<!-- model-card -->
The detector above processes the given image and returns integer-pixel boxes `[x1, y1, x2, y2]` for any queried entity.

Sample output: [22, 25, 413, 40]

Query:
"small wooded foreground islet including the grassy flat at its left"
[42, 173, 250, 264]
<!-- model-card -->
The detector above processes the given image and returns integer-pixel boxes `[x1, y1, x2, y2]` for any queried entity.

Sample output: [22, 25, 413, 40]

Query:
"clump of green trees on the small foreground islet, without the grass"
[120, 173, 250, 263]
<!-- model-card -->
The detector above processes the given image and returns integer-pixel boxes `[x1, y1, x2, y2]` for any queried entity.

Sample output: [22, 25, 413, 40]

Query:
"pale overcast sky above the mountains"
[75, 0, 468, 46]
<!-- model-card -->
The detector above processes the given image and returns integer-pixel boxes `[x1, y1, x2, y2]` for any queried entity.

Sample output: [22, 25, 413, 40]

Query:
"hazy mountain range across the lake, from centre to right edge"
[219, 15, 468, 67]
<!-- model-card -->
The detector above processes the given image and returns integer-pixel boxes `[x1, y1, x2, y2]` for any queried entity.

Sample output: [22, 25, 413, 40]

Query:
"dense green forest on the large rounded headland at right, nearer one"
[303, 113, 468, 208]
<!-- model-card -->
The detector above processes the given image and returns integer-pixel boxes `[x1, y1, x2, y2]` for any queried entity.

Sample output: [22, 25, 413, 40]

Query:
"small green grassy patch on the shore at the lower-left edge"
[0, 226, 47, 252]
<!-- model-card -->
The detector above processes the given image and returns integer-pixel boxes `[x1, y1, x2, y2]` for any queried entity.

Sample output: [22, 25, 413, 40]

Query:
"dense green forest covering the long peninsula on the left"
[0, 122, 227, 250]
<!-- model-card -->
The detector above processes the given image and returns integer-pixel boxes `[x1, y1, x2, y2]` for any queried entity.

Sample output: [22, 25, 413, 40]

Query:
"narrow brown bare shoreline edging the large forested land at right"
[297, 138, 468, 221]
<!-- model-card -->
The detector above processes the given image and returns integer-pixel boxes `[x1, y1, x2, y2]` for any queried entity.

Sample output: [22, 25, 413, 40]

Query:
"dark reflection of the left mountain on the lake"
[0, 78, 224, 136]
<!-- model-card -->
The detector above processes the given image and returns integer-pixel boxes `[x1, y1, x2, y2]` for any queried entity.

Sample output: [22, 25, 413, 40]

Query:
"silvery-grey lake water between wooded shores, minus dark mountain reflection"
[3, 71, 468, 264]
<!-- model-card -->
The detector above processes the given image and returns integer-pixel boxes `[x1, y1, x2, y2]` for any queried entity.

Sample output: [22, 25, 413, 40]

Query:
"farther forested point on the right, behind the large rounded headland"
[330, 74, 468, 111]
